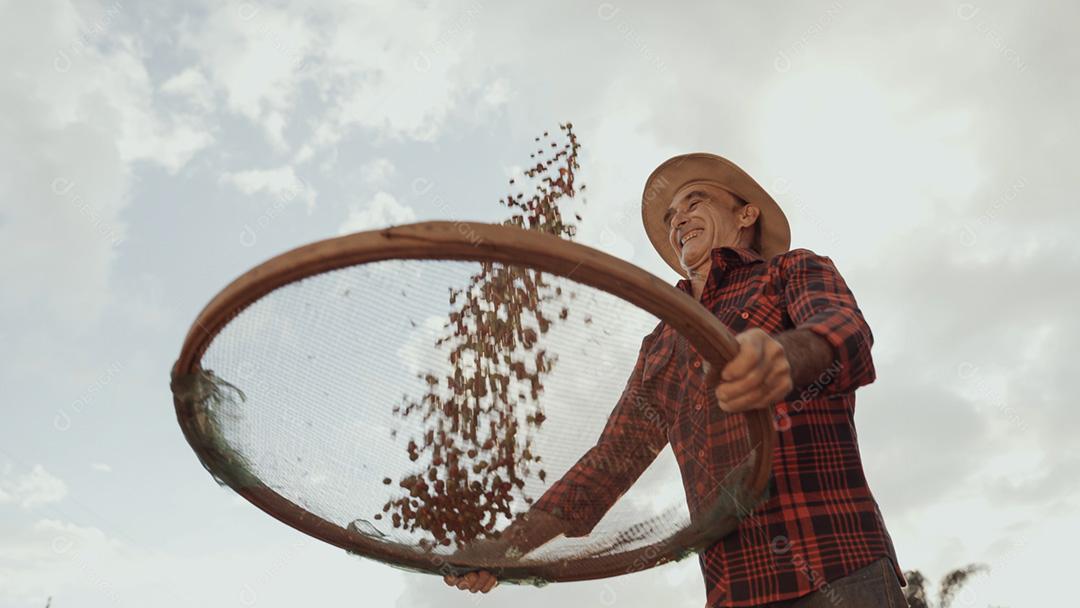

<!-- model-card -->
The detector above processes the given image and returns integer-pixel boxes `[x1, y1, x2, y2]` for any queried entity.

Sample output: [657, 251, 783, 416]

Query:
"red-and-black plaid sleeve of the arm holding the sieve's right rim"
[781, 249, 876, 396]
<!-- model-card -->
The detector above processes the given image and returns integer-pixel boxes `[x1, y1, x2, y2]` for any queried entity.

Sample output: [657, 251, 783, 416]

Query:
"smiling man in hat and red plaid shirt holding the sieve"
[446, 153, 906, 608]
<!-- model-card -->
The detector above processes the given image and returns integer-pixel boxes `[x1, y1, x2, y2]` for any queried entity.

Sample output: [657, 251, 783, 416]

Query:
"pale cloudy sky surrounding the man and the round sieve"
[0, 0, 1080, 608]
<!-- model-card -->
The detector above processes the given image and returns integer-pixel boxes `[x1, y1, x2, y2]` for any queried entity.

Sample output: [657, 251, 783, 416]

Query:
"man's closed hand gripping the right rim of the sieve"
[705, 327, 794, 413]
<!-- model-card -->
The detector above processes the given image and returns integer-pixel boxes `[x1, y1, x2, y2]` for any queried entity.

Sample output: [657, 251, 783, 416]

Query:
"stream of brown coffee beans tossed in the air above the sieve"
[380, 123, 592, 549]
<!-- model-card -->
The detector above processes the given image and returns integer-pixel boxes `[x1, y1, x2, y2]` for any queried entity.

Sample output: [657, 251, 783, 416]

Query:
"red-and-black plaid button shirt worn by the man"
[536, 247, 903, 606]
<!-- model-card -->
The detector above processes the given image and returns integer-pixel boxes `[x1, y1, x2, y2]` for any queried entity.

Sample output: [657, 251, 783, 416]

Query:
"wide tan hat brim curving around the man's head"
[642, 152, 792, 276]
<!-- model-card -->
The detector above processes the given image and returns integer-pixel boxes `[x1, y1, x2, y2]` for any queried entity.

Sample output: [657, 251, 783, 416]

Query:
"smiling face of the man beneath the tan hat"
[664, 183, 741, 270]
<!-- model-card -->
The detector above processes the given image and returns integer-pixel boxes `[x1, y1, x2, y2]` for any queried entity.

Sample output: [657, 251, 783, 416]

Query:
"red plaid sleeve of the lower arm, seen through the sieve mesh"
[532, 325, 667, 537]
